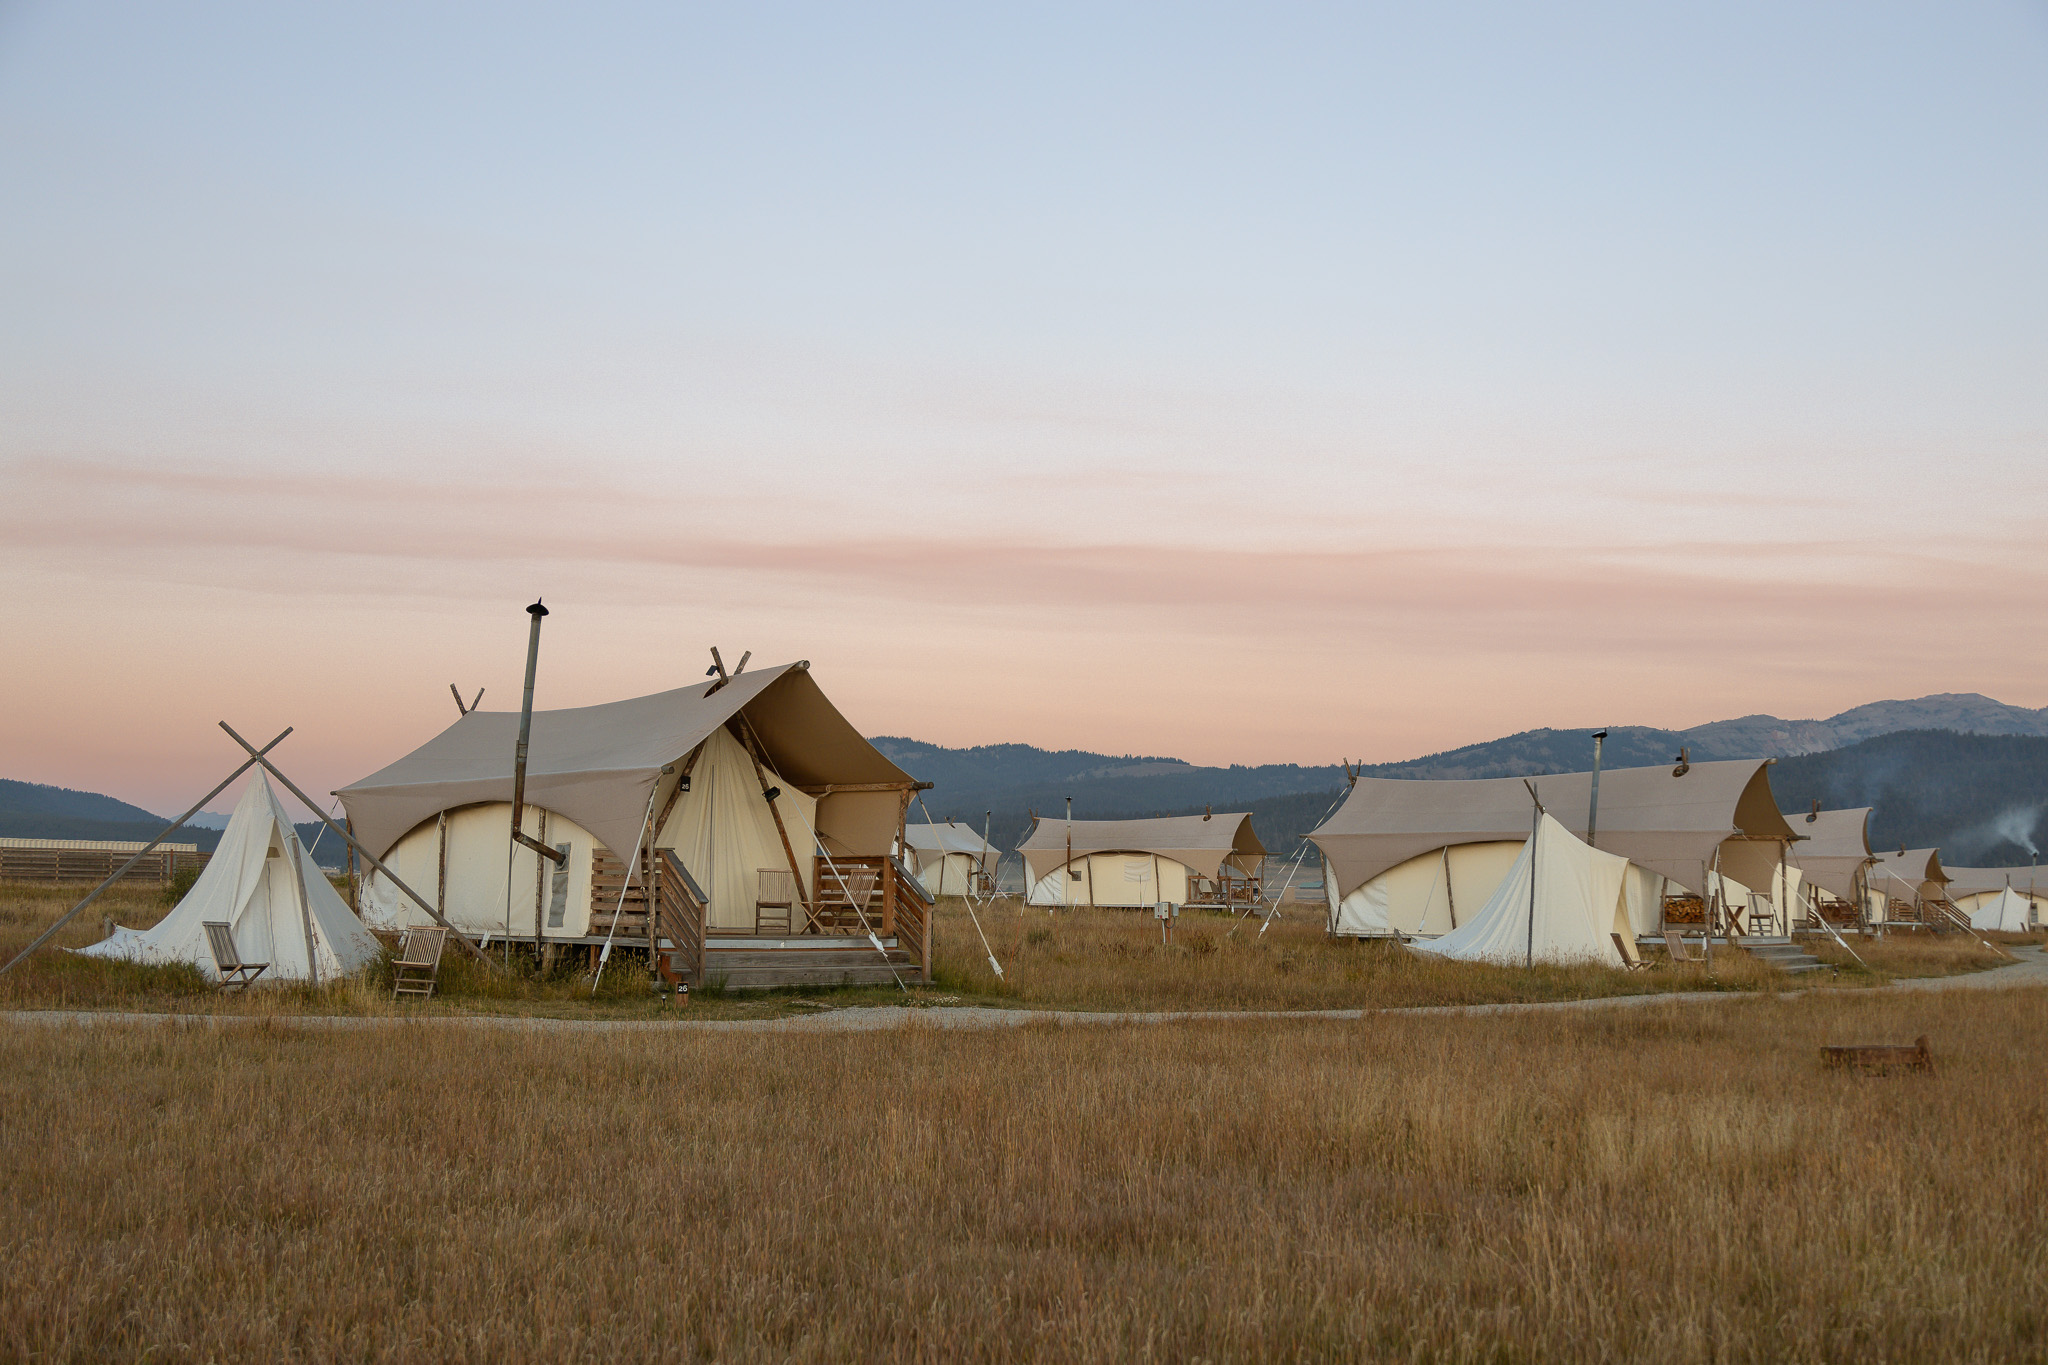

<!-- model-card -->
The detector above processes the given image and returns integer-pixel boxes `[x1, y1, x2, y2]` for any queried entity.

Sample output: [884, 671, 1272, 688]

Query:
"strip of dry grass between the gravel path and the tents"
[0, 884, 2005, 1019]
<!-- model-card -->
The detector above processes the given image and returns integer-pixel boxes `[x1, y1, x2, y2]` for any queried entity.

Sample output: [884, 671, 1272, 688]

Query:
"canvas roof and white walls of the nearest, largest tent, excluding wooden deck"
[338, 663, 918, 941]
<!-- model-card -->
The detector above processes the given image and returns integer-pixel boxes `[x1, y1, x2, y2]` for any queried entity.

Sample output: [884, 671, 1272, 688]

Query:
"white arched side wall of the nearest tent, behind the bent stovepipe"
[356, 802, 598, 939]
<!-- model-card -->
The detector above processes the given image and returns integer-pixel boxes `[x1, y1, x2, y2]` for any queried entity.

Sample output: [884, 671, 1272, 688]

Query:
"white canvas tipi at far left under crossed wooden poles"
[80, 776, 379, 980]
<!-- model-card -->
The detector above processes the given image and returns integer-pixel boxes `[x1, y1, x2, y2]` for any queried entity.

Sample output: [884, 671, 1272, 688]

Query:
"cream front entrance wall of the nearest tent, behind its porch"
[655, 729, 815, 931]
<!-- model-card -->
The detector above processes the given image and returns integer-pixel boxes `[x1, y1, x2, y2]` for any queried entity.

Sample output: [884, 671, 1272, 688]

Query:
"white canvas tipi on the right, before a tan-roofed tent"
[1411, 814, 1634, 966]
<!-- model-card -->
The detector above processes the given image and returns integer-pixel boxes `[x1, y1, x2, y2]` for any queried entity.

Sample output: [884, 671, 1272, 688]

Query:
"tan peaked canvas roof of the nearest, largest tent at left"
[336, 663, 911, 855]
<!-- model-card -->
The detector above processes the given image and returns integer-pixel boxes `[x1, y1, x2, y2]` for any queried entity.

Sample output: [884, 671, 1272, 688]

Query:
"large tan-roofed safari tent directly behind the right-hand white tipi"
[1309, 759, 1792, 937]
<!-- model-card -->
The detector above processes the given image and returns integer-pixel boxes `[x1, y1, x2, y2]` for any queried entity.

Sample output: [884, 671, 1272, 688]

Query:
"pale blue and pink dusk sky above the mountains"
[0, 0, 2048, 812]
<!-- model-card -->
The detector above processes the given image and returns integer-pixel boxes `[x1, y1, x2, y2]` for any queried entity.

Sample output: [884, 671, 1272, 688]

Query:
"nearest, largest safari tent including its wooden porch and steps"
[338, 663, 930, 984]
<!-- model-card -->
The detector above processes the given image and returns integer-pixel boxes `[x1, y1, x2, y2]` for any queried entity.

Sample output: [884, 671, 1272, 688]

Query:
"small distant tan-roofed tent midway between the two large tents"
[1018, 812, 1266, 907]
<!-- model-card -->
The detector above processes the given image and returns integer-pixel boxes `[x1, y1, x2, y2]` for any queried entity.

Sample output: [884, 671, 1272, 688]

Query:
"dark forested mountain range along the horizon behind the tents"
[0, 692, 2048, 866]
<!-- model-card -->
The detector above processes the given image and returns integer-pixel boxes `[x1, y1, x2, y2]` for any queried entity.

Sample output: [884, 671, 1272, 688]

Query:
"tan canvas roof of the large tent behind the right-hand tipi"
[1309, 759, 1792, 898]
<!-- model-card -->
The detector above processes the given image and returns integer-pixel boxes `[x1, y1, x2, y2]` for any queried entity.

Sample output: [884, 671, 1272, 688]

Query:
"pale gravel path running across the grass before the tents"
[0, 948, 2048, 1033]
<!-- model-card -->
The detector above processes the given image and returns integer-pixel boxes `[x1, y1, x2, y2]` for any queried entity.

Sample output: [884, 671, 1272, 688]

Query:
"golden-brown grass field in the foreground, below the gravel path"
[0, 990, 2048, 1363]
